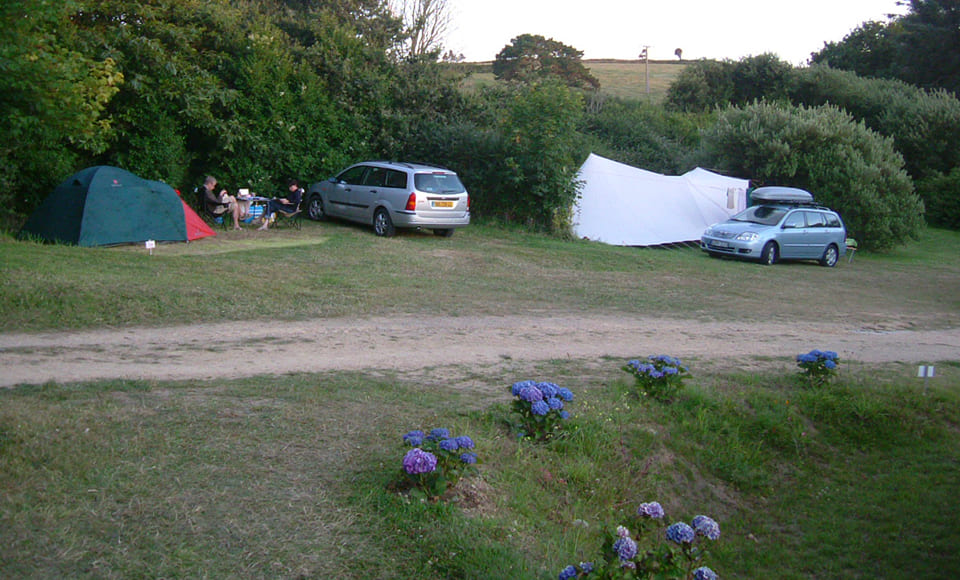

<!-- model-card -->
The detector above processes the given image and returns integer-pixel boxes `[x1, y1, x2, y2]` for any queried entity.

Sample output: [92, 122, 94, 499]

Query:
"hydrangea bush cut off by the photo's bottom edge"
[558, 502, 720, 580]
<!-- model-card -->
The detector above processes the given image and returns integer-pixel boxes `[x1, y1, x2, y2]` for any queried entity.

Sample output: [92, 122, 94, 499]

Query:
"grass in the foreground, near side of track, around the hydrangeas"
[0, 360, 960, 579]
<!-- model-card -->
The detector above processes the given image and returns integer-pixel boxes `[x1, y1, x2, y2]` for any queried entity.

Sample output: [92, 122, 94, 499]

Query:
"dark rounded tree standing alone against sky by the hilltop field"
[493, 34, 600, 89]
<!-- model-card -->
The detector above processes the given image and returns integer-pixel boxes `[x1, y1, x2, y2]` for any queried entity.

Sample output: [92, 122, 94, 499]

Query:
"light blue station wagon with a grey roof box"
[700, 187, 847, 267]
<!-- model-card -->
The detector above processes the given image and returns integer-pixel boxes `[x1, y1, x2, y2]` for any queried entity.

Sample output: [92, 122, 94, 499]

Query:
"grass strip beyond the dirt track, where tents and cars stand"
[0, 223, 960, 330]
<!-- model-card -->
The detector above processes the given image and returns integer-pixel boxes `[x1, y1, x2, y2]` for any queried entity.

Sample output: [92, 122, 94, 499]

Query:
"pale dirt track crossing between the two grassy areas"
[0, 315, 960, 387]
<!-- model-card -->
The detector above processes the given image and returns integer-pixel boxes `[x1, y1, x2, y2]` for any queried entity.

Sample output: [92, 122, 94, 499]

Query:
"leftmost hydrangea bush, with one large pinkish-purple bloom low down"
[400, 428, 477, 500]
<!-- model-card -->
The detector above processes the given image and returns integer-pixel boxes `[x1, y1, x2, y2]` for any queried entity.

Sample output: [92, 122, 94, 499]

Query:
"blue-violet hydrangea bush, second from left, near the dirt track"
[510, 381, 573, 441]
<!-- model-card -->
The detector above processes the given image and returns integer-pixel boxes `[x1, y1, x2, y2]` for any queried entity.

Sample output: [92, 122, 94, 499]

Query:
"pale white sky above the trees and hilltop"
[444, 0, 904, 65]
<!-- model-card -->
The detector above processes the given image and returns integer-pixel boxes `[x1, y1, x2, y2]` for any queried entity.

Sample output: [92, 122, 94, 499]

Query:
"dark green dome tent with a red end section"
[19, 165, 216, 246]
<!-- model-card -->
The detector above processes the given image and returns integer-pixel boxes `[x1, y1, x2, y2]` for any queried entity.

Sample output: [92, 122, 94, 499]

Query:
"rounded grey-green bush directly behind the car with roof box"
[703, 103, 923, 250]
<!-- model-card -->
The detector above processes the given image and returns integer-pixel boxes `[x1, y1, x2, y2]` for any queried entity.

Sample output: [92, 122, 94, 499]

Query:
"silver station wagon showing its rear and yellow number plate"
[306, 161, 470, 237]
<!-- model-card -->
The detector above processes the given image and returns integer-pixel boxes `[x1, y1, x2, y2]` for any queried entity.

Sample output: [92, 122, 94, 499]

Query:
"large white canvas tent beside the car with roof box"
[573, 153, 750, 246]
